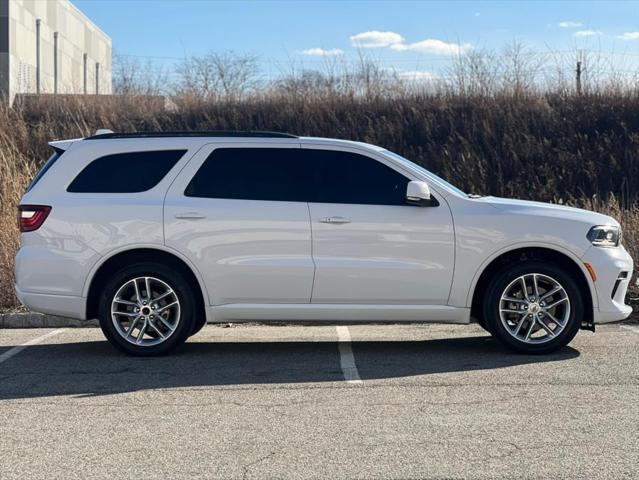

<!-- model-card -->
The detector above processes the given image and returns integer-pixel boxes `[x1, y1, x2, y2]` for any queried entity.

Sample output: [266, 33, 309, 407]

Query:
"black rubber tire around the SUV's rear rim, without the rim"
[98, 262, 196, 357]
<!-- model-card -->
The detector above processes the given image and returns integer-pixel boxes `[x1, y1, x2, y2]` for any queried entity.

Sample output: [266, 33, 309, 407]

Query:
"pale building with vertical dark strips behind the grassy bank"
[0, 0, 111, 101]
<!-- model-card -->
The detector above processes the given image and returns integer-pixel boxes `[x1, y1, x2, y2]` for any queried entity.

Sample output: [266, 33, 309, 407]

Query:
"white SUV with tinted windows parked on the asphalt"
[16, 132, 633, 355]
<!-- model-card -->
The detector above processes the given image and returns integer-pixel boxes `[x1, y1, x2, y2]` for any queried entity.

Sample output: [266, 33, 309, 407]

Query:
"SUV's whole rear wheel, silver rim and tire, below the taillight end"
[99, 263, 195, 356]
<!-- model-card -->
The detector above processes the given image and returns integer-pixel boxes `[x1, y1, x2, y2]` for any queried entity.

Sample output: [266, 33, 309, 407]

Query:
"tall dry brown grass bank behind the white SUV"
[0, 90, 639, 308]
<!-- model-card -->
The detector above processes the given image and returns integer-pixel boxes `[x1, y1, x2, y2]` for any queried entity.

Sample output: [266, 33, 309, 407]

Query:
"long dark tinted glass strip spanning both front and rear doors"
[184, 148, 408, 205]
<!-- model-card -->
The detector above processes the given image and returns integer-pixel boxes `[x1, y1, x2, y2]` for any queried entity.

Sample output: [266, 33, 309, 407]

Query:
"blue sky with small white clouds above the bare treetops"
[72, 0, 639, 81]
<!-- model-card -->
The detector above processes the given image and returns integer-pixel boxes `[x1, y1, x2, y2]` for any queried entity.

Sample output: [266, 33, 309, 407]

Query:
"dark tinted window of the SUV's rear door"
[184, 148, 310, 202]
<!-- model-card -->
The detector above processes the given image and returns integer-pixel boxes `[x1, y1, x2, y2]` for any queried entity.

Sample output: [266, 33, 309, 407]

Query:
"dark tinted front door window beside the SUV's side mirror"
[302, 149, 409, 205]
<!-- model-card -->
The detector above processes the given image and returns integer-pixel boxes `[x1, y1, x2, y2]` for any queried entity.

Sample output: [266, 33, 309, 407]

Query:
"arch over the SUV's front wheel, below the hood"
[468, 246, 597, 330]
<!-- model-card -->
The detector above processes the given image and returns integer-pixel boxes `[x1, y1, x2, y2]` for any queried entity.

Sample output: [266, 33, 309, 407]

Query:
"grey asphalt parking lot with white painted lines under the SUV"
[0, 323, 639, 480]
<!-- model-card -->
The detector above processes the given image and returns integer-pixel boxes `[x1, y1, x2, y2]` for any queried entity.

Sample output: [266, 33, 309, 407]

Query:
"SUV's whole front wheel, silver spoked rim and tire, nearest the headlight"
[484, 261, 584, 353]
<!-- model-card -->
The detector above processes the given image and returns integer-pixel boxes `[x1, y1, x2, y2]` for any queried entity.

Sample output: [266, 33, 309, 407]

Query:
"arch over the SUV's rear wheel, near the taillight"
[83, 246, 210, 321]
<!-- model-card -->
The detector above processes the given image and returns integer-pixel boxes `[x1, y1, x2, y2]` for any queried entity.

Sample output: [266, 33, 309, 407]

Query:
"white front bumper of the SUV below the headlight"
[582, 246, 633, 323]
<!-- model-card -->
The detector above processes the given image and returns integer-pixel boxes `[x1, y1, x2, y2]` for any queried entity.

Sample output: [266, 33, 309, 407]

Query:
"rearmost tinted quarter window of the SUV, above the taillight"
[67, 150, 186, 193]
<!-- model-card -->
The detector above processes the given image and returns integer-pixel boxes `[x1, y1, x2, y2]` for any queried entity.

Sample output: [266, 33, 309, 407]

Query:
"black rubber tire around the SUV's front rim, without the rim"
[483, 260, 584, 354]
